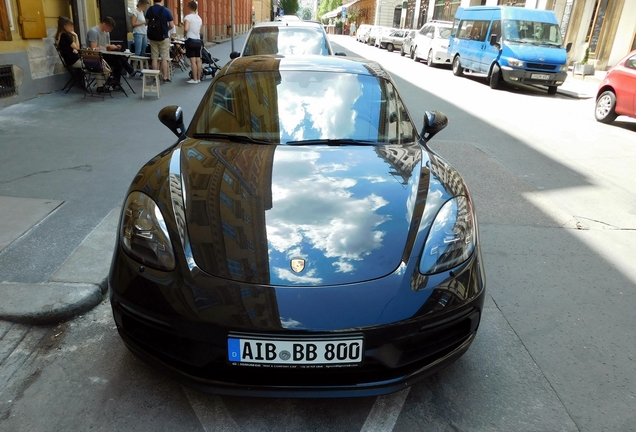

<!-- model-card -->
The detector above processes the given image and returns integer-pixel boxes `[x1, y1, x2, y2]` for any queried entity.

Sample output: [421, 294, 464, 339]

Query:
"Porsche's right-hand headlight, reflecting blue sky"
[420, 196, 475, 274]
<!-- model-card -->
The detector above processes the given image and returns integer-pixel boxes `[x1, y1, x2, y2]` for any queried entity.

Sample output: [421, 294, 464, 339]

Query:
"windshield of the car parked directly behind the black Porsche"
[243, 26, 331, 56]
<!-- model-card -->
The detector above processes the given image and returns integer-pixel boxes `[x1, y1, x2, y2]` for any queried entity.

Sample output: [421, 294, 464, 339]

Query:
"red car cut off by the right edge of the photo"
[594, 51, 636, 123]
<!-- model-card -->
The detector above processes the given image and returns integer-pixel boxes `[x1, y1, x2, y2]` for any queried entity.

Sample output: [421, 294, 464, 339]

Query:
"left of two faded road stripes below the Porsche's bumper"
[183, 387, 241, 432]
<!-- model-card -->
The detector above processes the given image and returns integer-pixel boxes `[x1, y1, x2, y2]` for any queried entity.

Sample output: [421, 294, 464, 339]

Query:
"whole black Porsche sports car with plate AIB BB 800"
[109, 56, 485, 397]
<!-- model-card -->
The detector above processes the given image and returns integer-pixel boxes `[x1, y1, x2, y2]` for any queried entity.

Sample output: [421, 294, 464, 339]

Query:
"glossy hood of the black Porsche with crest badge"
[180, 139, 429, 286]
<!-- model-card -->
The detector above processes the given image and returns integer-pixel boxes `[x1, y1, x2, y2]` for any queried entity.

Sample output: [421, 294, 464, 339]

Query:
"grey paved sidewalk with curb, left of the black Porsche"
[0, 36, 244, 326]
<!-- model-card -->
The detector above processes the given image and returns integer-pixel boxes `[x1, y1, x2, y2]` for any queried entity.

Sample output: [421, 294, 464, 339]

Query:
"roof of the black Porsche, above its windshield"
[224, 55, 391, 80]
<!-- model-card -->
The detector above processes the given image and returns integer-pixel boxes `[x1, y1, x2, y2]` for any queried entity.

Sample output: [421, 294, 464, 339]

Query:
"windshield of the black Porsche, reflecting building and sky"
[188, 70, 417, 144]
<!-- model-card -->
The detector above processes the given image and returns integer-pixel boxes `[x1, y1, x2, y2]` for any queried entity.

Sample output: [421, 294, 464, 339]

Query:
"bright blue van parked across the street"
[448, 6, 569, 94]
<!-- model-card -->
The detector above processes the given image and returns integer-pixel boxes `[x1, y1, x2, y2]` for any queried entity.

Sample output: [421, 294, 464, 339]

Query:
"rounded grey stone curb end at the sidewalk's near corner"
[0, 283, 104, 325]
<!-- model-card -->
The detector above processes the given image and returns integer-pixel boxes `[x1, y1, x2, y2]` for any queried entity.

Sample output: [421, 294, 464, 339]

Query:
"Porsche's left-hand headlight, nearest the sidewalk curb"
[119, 192, 174, 270]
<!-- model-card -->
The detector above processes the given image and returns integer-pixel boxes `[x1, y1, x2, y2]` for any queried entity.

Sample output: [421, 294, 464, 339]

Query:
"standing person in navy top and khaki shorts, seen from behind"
[146, 0, 174, 82]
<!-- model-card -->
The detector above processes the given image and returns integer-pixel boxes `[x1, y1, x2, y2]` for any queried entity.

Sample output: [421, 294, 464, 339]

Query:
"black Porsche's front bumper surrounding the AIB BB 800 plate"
[109, 246, 485, 398]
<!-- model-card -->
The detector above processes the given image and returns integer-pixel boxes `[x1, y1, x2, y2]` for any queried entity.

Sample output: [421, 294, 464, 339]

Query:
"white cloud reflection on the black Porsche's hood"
[266, 151, 390, 282]
